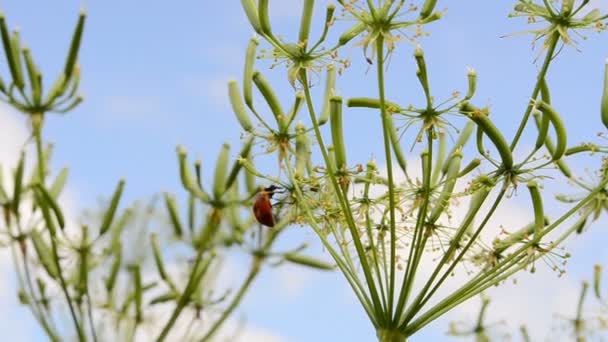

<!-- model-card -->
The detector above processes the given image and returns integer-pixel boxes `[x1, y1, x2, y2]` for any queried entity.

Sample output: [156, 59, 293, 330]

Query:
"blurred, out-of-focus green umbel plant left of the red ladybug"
[0, 6, 332, 341]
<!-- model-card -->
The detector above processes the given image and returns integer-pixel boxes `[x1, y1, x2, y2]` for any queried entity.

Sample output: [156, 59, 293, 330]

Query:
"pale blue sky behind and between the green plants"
[0, 0, 608, 341]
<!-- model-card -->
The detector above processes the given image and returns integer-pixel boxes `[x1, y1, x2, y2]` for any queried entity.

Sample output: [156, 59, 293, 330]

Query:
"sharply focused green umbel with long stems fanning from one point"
[228, 0, 608, 341]
